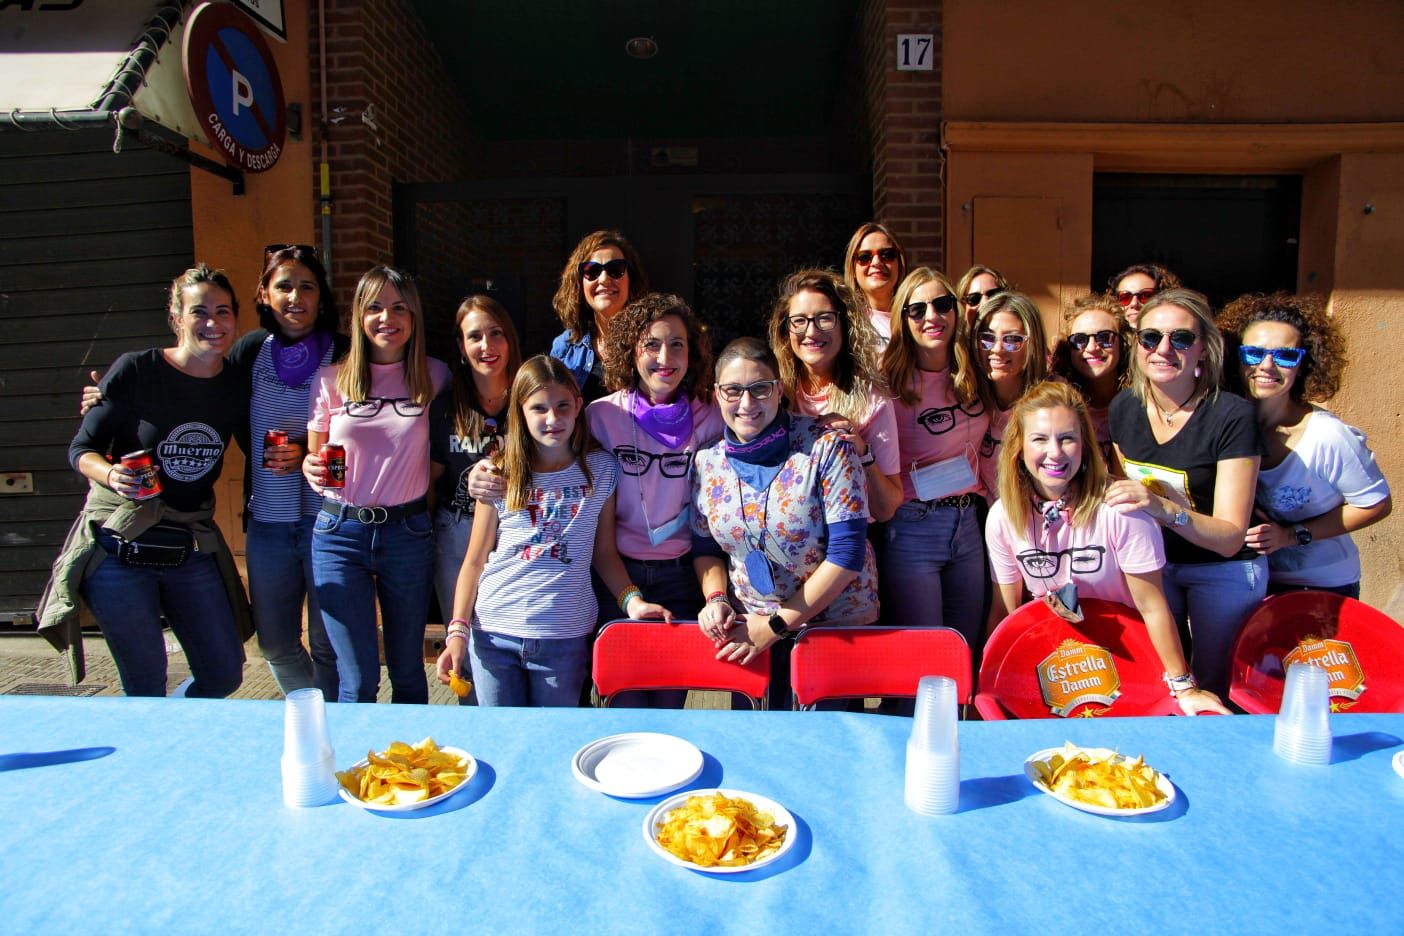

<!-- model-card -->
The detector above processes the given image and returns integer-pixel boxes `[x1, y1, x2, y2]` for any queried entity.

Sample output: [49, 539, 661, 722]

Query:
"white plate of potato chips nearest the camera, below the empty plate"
[643, 790, 795, 874]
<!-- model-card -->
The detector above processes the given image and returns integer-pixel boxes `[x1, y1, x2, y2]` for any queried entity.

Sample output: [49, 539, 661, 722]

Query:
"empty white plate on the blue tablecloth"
[570, 731, 702, 800]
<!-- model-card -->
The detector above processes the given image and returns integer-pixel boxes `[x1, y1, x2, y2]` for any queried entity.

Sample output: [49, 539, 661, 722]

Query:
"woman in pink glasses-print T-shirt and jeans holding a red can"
[302, 267, 449, 703]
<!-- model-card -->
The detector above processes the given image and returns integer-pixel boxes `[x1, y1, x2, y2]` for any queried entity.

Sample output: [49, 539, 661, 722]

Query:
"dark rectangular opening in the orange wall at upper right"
[1092, 173, 1302, 309]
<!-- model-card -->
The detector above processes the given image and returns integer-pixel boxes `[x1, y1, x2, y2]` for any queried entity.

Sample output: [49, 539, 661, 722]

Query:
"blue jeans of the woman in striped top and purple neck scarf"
[244, 516, 338, 700]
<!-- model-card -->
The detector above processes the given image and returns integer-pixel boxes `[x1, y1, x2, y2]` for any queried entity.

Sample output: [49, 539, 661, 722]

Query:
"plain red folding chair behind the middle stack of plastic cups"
[790, 627, 973, 709]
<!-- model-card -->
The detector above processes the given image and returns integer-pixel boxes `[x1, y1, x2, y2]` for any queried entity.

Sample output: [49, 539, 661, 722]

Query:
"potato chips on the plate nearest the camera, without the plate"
[656, 793, 789, 867]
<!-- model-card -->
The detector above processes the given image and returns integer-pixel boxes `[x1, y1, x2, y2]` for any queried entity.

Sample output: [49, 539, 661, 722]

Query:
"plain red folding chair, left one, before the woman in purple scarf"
[594, 620, 771, 709]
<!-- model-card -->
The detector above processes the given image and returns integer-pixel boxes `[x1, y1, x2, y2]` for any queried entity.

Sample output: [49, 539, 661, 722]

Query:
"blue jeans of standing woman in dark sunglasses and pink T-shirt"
[882, 501, 988, 660]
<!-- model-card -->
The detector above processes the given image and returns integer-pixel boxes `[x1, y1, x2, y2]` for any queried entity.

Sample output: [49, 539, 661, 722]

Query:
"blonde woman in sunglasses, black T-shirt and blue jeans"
[1106, 289, 1268, 696]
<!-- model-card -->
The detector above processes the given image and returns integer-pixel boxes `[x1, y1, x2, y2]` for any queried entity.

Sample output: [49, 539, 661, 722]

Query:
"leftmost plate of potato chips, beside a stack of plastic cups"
[337, 738, 477, 813]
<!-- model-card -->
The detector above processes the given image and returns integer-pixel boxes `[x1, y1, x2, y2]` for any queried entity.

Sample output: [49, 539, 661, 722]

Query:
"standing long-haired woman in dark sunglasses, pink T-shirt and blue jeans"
[882, 267, 990, 648]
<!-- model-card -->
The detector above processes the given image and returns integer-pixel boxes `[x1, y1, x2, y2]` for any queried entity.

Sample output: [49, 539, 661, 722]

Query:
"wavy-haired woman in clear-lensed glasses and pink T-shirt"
[769, 269, 903, 523]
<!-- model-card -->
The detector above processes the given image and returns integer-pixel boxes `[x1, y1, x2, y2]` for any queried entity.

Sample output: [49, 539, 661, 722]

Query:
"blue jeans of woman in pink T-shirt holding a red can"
[312, 507, 434, 703]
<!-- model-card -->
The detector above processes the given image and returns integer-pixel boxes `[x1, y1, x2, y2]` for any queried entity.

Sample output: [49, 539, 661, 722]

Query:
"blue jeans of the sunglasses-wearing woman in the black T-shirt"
[1163, 556, 1268, 699]
